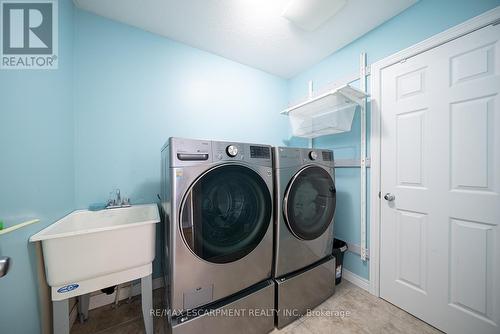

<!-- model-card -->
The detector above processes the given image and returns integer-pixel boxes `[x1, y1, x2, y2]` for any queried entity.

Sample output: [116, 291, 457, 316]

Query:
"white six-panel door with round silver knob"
[380, 25, 500, 334]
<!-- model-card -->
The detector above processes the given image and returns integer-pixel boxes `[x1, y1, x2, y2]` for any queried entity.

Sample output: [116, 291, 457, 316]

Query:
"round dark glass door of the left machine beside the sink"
[180, 165, 272, 263]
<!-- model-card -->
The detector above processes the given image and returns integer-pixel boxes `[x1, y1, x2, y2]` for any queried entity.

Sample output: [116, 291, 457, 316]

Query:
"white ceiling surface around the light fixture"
[74, 0, 418, 78]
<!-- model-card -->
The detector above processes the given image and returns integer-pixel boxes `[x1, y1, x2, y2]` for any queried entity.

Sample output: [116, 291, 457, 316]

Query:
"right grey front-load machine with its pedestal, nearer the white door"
[273, 147, 336, 328]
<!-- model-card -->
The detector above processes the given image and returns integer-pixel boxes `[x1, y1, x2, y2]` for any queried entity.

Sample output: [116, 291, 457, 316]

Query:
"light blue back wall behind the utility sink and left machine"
[74, 10, 288, 276]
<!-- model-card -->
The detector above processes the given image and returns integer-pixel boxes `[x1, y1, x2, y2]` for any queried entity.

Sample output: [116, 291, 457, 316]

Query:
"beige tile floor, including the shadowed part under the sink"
[71, 280, 441, 334]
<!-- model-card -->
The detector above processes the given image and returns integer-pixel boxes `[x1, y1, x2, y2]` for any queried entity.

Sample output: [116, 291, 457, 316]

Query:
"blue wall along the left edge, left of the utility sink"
[0, 1, 74, 333]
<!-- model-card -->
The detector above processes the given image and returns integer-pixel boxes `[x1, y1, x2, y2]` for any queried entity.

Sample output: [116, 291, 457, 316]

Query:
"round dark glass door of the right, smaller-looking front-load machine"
[283, 166, 336, 240]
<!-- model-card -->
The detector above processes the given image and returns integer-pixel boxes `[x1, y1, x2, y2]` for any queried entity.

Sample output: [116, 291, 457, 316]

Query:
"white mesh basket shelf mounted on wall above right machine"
[281, 85, 368, 138]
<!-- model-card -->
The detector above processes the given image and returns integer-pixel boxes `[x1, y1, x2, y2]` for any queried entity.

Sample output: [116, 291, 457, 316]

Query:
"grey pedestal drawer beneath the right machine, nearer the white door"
[276, 257, 335, 329]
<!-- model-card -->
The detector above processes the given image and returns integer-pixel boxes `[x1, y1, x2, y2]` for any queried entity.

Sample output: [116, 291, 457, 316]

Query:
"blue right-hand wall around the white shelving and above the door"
[288, 0, 500, 278]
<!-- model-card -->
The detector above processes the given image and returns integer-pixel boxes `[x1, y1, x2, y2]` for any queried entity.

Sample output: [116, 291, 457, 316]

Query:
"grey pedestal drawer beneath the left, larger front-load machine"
[169, 280, 274, 334]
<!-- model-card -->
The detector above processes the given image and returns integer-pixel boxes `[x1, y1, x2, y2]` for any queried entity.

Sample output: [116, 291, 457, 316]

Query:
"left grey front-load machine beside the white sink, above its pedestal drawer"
[161, 138, 274, 333]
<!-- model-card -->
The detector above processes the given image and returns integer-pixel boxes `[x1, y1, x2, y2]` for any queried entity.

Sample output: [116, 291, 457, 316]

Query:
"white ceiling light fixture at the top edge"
[281, 0, 347, 31]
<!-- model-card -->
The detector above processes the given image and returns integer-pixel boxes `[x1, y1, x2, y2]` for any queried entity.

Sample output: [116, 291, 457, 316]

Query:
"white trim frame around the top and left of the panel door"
[370, 6, 500, 297]
